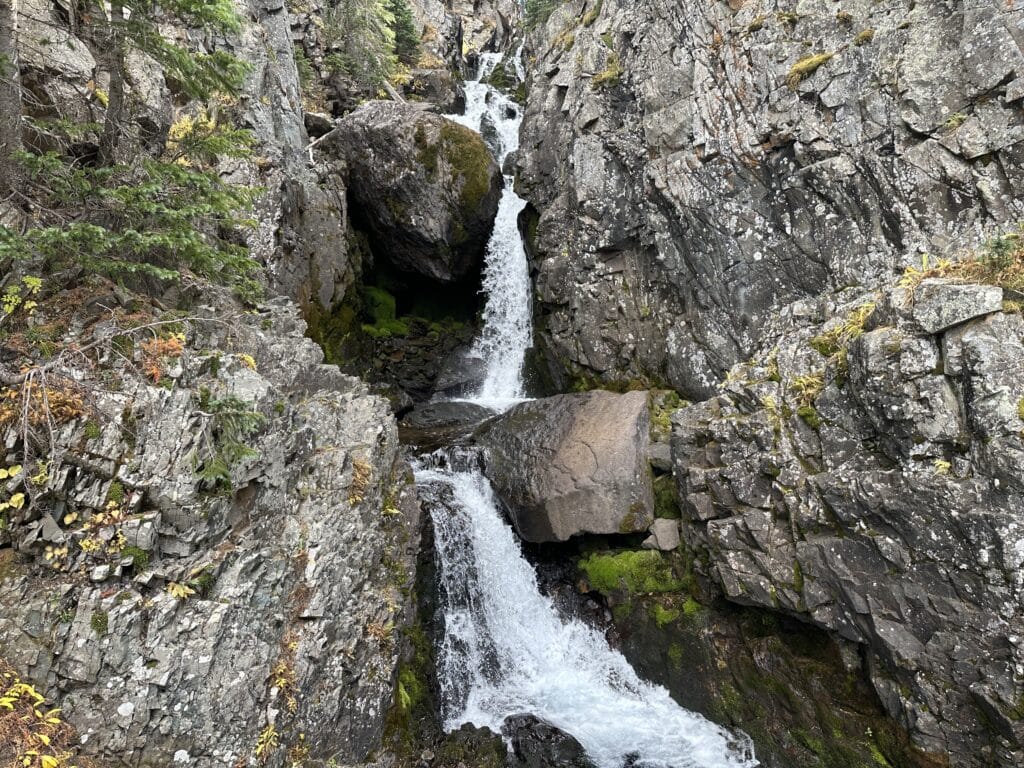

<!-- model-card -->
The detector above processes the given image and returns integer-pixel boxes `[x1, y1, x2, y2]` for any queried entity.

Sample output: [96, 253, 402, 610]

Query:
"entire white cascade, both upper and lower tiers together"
[416, 48, 758, 768]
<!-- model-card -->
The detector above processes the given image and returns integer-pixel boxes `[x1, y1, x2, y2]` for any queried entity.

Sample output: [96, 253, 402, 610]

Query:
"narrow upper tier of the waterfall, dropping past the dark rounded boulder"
[445, 47, 532, 410]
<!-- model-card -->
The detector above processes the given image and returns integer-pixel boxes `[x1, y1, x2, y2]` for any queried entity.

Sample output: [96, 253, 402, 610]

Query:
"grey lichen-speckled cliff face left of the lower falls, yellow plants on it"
[0, 296, 419, 766]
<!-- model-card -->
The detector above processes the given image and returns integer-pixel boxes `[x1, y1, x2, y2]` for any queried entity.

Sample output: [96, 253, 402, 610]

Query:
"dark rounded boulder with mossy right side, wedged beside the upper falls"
[325, 101, 502, 284]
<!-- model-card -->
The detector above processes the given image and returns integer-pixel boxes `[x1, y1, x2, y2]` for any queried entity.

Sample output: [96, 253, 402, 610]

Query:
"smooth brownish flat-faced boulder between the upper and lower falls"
[479, 391, 654, 542]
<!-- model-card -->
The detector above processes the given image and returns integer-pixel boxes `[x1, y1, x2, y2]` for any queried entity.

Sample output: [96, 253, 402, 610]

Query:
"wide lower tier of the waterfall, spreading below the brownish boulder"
[416, 462, 758, 768]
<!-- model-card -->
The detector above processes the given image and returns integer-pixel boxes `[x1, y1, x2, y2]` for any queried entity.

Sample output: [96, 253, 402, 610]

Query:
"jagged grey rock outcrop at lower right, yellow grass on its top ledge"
[673, 281, 1024, 766]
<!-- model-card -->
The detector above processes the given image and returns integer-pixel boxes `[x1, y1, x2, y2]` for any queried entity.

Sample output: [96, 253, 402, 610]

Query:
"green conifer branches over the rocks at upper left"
[0, 0, 258, 299]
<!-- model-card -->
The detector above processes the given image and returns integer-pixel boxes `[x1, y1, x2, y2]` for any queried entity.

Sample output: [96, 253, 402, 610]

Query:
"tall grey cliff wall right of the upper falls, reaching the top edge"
[519, 0, 1024, 396]
